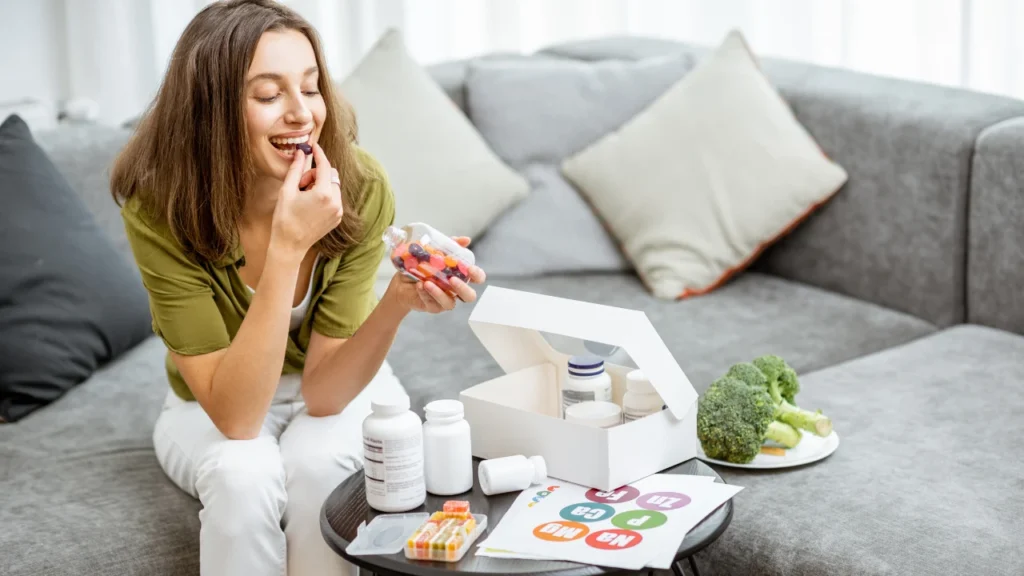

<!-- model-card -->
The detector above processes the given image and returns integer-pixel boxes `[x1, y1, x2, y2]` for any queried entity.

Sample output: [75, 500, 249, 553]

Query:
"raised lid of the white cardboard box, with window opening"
[469, 286, 697, 418]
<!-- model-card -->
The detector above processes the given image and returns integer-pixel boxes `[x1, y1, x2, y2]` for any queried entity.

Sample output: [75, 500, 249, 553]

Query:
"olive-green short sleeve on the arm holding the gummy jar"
[313, 153, 394, 338]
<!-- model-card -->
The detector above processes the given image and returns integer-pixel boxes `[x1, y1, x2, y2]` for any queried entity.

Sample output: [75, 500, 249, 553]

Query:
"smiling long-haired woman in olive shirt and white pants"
[112, 0, 484, 576]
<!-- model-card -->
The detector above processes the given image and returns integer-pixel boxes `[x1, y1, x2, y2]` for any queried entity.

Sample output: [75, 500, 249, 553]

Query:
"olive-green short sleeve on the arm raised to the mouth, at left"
[121, 201, 230, 356]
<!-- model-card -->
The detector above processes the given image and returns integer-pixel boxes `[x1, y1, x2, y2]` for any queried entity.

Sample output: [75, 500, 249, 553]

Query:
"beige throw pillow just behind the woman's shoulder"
[339, 30, 529, 262]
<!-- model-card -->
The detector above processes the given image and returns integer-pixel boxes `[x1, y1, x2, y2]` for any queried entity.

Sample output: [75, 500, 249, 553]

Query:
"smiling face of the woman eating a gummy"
[245, 30, 327, 180]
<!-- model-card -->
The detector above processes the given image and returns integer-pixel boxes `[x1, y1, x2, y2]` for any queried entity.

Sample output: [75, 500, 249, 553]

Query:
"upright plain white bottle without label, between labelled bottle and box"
[423, 400, 473, 496]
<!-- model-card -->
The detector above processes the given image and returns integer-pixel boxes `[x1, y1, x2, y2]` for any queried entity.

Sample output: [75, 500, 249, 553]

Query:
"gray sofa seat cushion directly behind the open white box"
[388, 273, 934, 410]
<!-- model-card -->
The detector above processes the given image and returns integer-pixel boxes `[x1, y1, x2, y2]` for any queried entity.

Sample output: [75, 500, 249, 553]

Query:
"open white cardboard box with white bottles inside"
[460, 286, 697, 490]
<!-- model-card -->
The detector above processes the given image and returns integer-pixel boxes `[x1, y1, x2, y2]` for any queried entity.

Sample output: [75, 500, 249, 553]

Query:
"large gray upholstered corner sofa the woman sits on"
[6, 38, 1024, 576]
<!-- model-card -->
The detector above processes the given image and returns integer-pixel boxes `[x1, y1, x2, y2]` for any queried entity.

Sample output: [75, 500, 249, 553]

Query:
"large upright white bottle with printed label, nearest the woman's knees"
[362, 395, 427, 512]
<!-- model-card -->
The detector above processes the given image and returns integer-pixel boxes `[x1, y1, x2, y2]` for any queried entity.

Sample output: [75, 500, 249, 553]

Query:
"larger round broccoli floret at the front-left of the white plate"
[697, 376, 800, 463]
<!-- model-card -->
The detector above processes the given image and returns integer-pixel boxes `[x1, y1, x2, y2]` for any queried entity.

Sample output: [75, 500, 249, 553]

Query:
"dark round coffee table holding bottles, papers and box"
[321, 458, 732, 576]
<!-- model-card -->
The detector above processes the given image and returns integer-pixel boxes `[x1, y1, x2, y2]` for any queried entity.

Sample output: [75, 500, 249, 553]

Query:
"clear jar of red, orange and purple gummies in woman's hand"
[384, 222, 476, 295]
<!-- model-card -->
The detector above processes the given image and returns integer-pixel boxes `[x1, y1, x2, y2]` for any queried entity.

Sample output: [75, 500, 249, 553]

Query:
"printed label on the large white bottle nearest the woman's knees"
[362, 434, 424, 502]
